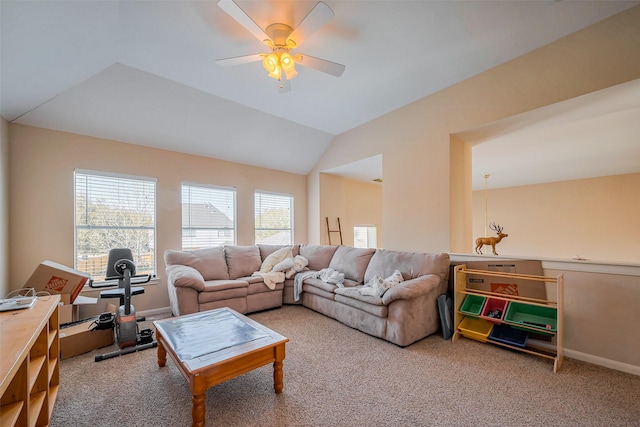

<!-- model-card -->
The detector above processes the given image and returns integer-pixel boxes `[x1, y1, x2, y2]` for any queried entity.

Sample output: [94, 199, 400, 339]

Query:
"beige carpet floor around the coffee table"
[51, 306, 640, 427]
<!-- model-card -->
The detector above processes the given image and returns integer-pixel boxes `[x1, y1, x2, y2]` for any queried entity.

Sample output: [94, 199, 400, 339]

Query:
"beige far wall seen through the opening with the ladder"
[320, 174, 384, 247]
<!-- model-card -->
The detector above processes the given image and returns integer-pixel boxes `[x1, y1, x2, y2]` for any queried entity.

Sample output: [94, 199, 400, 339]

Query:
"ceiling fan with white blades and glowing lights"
[216, 0, 345, 92]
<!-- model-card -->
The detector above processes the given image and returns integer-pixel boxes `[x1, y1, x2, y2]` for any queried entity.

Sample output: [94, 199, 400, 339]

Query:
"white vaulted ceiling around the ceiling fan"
[0, 0, 640, 179]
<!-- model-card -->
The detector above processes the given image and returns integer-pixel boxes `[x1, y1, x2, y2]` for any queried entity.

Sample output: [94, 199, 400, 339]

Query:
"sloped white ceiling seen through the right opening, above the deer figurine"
[456, 80, 640, 190]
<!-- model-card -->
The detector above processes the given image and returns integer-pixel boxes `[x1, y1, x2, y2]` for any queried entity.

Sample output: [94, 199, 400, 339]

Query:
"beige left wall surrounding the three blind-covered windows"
[9, 125, 307, 311]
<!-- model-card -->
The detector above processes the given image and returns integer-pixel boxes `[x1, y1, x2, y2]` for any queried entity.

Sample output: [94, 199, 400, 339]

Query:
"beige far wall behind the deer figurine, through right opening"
[473, 174, 640, 264]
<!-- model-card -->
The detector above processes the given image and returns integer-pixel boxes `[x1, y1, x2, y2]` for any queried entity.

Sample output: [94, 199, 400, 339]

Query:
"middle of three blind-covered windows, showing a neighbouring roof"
[182, 184, 236, 250]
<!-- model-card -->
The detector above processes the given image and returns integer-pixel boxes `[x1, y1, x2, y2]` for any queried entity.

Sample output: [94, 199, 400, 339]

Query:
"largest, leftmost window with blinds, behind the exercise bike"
[74, 171, 156, 281]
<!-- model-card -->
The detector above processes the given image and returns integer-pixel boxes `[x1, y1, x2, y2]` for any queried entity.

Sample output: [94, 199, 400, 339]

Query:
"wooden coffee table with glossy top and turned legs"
[153, 307, 289, 426]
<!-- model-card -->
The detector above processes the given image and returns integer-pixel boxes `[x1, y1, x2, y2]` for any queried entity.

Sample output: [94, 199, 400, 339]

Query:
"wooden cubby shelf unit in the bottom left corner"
[0, 295, 60, 427]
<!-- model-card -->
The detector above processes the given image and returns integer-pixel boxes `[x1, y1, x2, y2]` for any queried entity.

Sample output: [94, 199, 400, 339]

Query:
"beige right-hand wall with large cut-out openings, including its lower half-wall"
[307, 7, 640, 372]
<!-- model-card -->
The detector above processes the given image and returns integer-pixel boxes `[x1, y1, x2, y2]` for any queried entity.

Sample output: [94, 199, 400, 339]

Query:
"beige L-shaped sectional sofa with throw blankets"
[164, 244, 449, 346]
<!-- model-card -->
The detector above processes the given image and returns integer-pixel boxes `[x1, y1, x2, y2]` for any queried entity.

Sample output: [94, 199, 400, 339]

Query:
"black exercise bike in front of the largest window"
[95, 252, 158, 362]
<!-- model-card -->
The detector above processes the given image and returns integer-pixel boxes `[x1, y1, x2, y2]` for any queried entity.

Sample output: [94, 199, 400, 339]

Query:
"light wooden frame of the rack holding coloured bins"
[451, 265, 564, 372]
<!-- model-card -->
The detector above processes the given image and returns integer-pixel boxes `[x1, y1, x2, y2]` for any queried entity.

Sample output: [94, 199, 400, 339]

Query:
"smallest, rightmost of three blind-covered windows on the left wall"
[254, 192, 293, 245]
